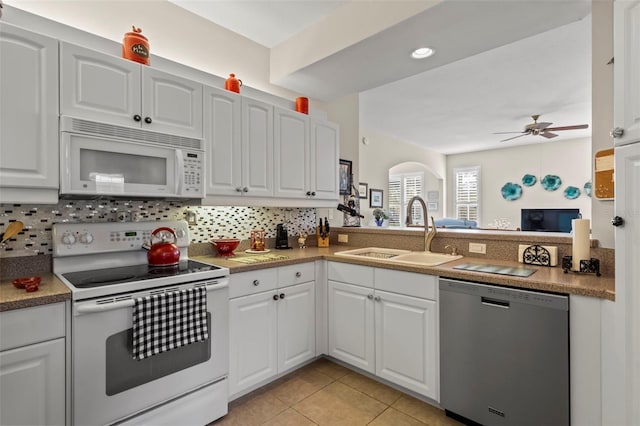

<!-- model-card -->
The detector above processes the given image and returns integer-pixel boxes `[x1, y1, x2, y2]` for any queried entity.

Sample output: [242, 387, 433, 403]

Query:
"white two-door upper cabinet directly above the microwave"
[60, 42, 203, 139]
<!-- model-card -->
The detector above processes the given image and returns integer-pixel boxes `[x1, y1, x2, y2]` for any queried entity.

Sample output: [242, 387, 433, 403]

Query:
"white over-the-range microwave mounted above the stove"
[60, 117, 205, 199]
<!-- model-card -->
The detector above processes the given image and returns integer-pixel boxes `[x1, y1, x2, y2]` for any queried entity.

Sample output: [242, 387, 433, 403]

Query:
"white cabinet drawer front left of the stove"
[0, 302, 66, 351]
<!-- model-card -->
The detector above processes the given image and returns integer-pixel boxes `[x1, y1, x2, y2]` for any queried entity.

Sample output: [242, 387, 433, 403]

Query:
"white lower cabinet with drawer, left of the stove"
[0, 303, 66, 425]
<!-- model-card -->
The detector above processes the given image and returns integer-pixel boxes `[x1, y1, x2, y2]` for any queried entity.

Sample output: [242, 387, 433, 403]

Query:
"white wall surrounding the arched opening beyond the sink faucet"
[358, 129, 446, 224]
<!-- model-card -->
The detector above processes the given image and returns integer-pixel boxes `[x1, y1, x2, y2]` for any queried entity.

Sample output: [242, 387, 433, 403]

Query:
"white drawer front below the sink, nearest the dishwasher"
[375, 268, 438, 300]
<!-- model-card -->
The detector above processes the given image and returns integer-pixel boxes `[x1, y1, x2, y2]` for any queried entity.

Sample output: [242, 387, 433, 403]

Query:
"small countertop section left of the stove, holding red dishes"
[0, 272, 71, 312]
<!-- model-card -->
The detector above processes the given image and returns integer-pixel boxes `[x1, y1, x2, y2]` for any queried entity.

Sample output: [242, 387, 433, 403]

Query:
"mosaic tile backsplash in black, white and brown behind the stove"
[0, 200, 316, 258]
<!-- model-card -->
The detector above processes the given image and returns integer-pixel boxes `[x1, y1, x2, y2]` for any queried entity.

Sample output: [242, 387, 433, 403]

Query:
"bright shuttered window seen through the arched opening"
[388, 173, 424, 226]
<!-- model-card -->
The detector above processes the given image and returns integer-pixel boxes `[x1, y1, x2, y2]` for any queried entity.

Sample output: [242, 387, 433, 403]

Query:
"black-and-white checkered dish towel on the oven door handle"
[133, 287, 209, 360]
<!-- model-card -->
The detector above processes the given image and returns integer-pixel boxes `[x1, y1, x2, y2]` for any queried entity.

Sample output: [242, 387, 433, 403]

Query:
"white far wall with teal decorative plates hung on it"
[446, 138, 591, 228]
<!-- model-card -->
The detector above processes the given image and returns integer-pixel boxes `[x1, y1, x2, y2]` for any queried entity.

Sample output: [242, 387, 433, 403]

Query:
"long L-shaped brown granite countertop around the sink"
[192, 246, 615, 300]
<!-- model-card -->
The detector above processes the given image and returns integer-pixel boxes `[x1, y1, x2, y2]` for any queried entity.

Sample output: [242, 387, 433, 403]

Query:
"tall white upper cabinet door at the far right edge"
[613, 0, 640, 145]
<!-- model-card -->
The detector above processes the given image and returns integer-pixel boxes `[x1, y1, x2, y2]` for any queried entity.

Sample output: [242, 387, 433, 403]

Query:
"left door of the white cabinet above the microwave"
[60, 42, 141, 127]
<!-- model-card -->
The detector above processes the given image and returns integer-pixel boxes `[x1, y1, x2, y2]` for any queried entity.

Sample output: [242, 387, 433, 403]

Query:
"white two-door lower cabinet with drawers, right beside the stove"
[229, 262, 316, 399]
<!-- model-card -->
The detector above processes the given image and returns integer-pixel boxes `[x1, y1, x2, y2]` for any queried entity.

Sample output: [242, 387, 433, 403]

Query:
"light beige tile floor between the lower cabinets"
[211, 358, 459, 426]
